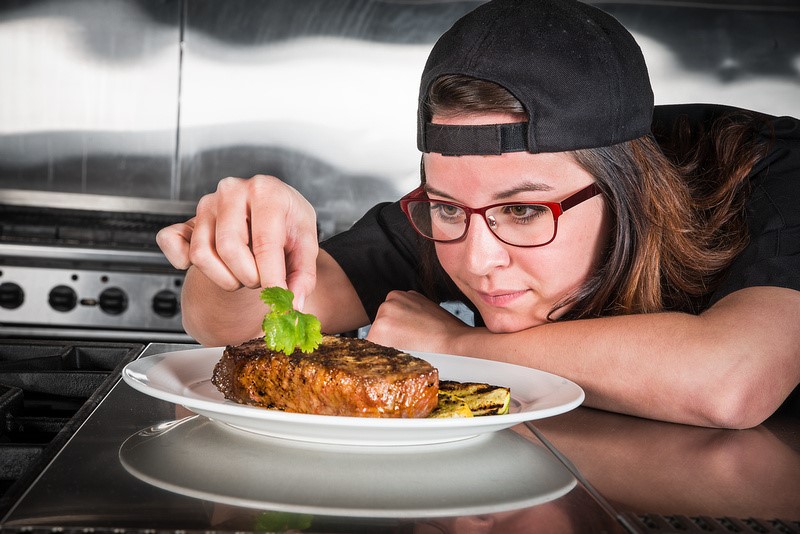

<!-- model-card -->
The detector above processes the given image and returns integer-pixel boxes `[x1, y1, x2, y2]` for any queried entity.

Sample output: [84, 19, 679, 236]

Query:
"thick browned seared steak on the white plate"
[211, 336, 439, 417]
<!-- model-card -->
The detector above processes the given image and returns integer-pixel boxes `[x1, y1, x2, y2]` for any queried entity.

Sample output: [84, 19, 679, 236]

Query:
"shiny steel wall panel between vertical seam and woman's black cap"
[180, 0, 480, 239]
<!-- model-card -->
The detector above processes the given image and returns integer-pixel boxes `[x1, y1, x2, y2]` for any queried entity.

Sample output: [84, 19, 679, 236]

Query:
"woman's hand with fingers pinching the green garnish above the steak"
[156, 175, 318, 308]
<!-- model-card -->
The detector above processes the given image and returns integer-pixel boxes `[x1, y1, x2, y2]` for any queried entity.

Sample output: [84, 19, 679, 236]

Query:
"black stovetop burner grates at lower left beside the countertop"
[0, 339, 144, 517]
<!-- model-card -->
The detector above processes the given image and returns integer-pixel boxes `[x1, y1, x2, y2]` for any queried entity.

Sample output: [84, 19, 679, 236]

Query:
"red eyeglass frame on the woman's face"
[400, 182, 603, 248]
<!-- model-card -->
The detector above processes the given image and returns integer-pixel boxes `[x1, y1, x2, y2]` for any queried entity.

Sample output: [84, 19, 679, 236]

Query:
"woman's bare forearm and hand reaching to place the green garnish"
[157, 175, 367, 345]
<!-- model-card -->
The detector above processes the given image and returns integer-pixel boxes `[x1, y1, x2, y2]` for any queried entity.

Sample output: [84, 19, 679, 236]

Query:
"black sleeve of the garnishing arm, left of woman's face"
[320, 202, 421, 321]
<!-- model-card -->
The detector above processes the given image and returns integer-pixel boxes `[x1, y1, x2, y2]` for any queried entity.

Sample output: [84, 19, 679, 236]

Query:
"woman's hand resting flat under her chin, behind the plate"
[367, 291, 472, 354]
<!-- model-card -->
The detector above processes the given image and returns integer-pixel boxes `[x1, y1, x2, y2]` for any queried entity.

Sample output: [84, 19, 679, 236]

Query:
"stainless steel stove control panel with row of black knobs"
[0, 240, 191, 341]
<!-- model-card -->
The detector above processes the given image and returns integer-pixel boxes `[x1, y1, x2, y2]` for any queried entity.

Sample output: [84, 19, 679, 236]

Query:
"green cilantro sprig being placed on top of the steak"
[261, 287, 322, 355]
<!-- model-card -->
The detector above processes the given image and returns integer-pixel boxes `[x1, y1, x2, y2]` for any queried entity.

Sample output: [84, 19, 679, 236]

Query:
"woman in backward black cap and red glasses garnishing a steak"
[159, 0, 800, 428]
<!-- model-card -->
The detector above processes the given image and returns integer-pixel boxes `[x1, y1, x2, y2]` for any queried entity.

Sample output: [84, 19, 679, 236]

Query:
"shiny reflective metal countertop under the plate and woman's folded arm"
[0, 343, 800, 534]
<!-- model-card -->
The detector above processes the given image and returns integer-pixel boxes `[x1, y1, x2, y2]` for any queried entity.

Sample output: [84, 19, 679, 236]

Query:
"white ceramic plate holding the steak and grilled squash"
[122, 347, 584, 446]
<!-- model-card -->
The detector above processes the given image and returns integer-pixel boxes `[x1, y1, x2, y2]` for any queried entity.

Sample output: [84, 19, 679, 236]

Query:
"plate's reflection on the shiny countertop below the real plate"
[119, 415, 576, 517]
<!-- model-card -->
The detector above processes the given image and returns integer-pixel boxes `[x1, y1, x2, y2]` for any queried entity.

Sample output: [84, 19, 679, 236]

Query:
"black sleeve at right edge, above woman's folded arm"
[709, 112, 800, 305]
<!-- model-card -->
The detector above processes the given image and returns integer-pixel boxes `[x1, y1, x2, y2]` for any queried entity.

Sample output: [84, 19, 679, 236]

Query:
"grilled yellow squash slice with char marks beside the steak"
[428, 380, 511, 418]
